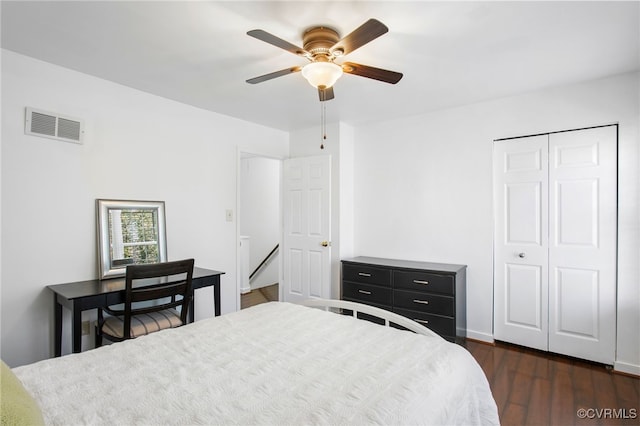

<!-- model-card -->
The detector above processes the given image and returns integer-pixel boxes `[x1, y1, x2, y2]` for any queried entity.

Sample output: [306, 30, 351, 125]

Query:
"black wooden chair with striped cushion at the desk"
[96, 259, 194, 347]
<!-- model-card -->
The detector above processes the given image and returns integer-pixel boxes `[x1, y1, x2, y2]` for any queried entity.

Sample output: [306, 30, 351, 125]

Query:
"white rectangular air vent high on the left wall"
[24, 108, 84, 143]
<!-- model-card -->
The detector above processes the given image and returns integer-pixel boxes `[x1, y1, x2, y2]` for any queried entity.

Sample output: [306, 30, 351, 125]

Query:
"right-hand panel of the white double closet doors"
[549, 126, 617, 364]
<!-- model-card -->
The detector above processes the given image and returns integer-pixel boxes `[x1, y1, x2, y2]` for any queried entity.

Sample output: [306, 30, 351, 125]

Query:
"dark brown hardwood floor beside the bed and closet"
[464, 340, 640, 426]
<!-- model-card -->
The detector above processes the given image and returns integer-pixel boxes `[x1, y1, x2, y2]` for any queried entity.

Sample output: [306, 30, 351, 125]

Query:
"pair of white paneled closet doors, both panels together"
[494, 126, 617, 364]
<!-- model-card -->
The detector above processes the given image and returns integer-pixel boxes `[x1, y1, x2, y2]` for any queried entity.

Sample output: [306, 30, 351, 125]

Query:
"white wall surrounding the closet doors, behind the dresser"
[354, 73, 640, 374]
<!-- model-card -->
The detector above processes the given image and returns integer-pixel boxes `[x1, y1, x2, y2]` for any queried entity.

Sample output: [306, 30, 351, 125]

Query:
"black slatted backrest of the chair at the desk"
[124, 259, 194, 339]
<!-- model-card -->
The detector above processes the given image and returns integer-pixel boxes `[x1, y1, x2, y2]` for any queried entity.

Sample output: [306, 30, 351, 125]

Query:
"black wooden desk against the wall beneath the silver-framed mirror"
[47, 267, 224, 356]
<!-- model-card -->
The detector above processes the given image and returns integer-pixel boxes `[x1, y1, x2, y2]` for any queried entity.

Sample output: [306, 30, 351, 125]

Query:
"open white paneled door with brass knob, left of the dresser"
[281, 155, 331, 303]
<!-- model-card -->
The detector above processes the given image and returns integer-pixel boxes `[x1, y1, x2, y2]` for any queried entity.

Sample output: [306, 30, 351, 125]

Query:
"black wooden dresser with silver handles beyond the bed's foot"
[342, 257, 467, 341]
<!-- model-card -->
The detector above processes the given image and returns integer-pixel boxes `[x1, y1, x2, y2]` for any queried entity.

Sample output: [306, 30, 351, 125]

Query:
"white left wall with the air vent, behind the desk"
[0, 50, 288, 366]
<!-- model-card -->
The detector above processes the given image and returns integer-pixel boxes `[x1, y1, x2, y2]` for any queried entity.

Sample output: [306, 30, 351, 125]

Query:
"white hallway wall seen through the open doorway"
[239, 156, 282, 290]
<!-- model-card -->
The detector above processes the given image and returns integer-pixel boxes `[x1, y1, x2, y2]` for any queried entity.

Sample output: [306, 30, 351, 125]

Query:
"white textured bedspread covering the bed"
[14, 302, 499, 425]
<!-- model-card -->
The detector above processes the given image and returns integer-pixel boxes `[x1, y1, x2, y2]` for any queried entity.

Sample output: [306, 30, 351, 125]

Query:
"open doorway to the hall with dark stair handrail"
[238, 152, 282, 309]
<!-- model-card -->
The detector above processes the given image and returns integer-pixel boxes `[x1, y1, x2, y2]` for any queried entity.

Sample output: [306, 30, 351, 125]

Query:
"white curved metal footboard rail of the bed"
[302, 298, 442, 339]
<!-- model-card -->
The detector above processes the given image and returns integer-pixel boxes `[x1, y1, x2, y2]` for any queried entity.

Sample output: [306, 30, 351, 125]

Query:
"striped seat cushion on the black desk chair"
[102, 309, 182, 338]
